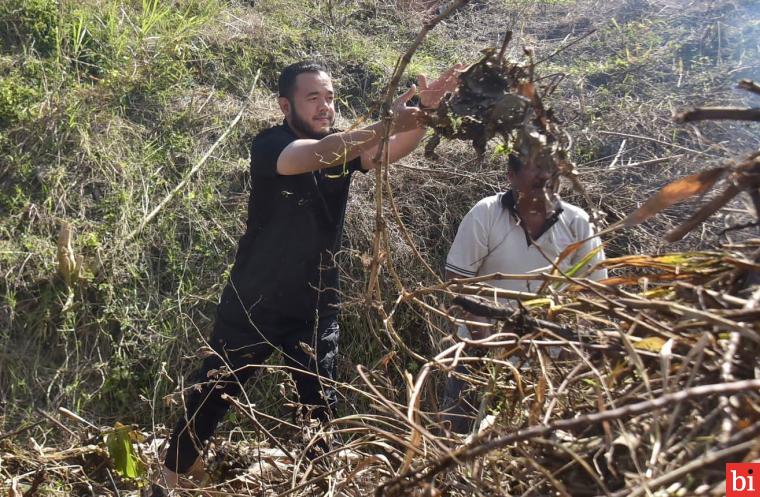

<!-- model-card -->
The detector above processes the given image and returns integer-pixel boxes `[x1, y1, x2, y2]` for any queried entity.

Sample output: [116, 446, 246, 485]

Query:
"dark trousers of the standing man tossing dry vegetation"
[165, 289, 340, 473]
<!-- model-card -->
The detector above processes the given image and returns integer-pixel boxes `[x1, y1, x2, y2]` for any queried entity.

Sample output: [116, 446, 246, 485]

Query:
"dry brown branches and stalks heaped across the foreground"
[0, 1, 760, 497]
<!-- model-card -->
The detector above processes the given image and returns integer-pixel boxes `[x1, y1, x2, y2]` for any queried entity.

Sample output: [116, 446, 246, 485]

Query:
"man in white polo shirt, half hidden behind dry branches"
[444, 154, 607, 433]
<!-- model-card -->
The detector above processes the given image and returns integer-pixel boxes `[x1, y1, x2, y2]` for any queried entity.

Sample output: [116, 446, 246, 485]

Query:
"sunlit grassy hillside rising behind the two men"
[0, 0, 760, 494]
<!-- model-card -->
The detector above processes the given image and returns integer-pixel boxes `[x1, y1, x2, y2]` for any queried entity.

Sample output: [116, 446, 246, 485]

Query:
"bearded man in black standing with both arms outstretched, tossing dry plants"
[154, 61, 461, 495]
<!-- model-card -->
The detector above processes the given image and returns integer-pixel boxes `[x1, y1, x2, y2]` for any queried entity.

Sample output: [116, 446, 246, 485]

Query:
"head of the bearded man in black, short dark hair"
[279, 71, 335, 139]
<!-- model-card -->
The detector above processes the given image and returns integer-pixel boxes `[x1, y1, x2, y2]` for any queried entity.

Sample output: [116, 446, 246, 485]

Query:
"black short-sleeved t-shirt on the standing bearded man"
[223, 123, 361, 319]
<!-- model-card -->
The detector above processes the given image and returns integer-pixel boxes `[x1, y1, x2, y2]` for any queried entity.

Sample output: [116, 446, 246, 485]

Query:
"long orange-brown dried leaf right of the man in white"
[623, 167, 726, 226]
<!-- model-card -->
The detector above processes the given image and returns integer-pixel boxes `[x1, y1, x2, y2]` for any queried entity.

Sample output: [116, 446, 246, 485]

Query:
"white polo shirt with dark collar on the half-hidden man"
[446, 191, 607, 292]
